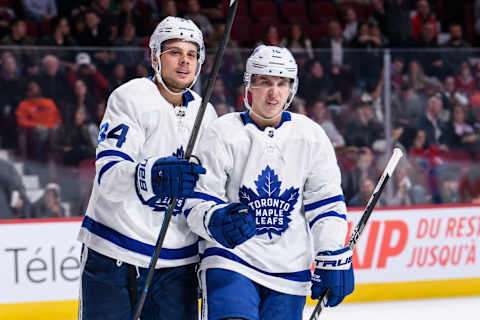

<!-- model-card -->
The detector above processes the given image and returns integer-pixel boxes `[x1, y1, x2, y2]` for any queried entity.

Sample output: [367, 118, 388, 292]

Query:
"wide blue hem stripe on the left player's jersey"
[82, 216, 198, 260]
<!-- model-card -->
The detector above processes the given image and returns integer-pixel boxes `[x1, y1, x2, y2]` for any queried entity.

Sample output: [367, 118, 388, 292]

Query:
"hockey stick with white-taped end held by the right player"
[310, 148, 403, 320]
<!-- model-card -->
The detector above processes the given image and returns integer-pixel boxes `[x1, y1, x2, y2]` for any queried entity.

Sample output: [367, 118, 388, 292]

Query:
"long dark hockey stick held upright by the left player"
[133, 0, 240, 320]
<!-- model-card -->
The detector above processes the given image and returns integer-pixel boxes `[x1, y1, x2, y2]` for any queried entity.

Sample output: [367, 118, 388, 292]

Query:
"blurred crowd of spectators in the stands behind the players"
[0, 0, 480, 217]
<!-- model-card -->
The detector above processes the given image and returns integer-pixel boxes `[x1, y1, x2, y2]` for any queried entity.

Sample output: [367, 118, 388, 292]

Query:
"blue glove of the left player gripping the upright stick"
[136, 156, 206, 202]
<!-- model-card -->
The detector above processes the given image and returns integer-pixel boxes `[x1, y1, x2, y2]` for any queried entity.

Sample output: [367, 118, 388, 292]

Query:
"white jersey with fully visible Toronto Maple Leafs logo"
[186, 112, 347, 295]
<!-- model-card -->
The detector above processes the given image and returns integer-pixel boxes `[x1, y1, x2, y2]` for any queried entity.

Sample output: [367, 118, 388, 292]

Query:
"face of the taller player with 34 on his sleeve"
[160, 40, 198, 92]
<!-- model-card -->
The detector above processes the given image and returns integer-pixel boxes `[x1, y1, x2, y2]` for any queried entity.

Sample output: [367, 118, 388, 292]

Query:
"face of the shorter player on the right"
[249, 75, 290, 118]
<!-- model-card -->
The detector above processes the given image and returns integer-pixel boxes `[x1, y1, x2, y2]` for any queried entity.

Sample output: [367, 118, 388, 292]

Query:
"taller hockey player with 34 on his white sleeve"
[79, 17, 216, 320]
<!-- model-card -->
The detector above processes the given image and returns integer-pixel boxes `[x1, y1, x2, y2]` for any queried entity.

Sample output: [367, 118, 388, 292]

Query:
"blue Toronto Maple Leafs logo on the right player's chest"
[238, 166, 299, 239]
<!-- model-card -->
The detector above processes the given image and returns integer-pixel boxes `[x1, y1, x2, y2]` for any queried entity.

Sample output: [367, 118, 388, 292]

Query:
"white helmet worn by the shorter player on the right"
[243, 44, 298, 120]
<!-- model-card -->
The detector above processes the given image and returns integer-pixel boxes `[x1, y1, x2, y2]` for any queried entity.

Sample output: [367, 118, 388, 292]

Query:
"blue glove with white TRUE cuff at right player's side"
[312, 247, 355, 307]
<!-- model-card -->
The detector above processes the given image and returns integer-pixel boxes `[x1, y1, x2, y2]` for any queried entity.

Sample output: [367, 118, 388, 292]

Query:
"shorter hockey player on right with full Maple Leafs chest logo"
[187, 45, 354, 320]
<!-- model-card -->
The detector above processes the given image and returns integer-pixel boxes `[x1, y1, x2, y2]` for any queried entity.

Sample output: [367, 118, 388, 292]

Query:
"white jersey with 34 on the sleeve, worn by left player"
[78, 78, 217, 268]
